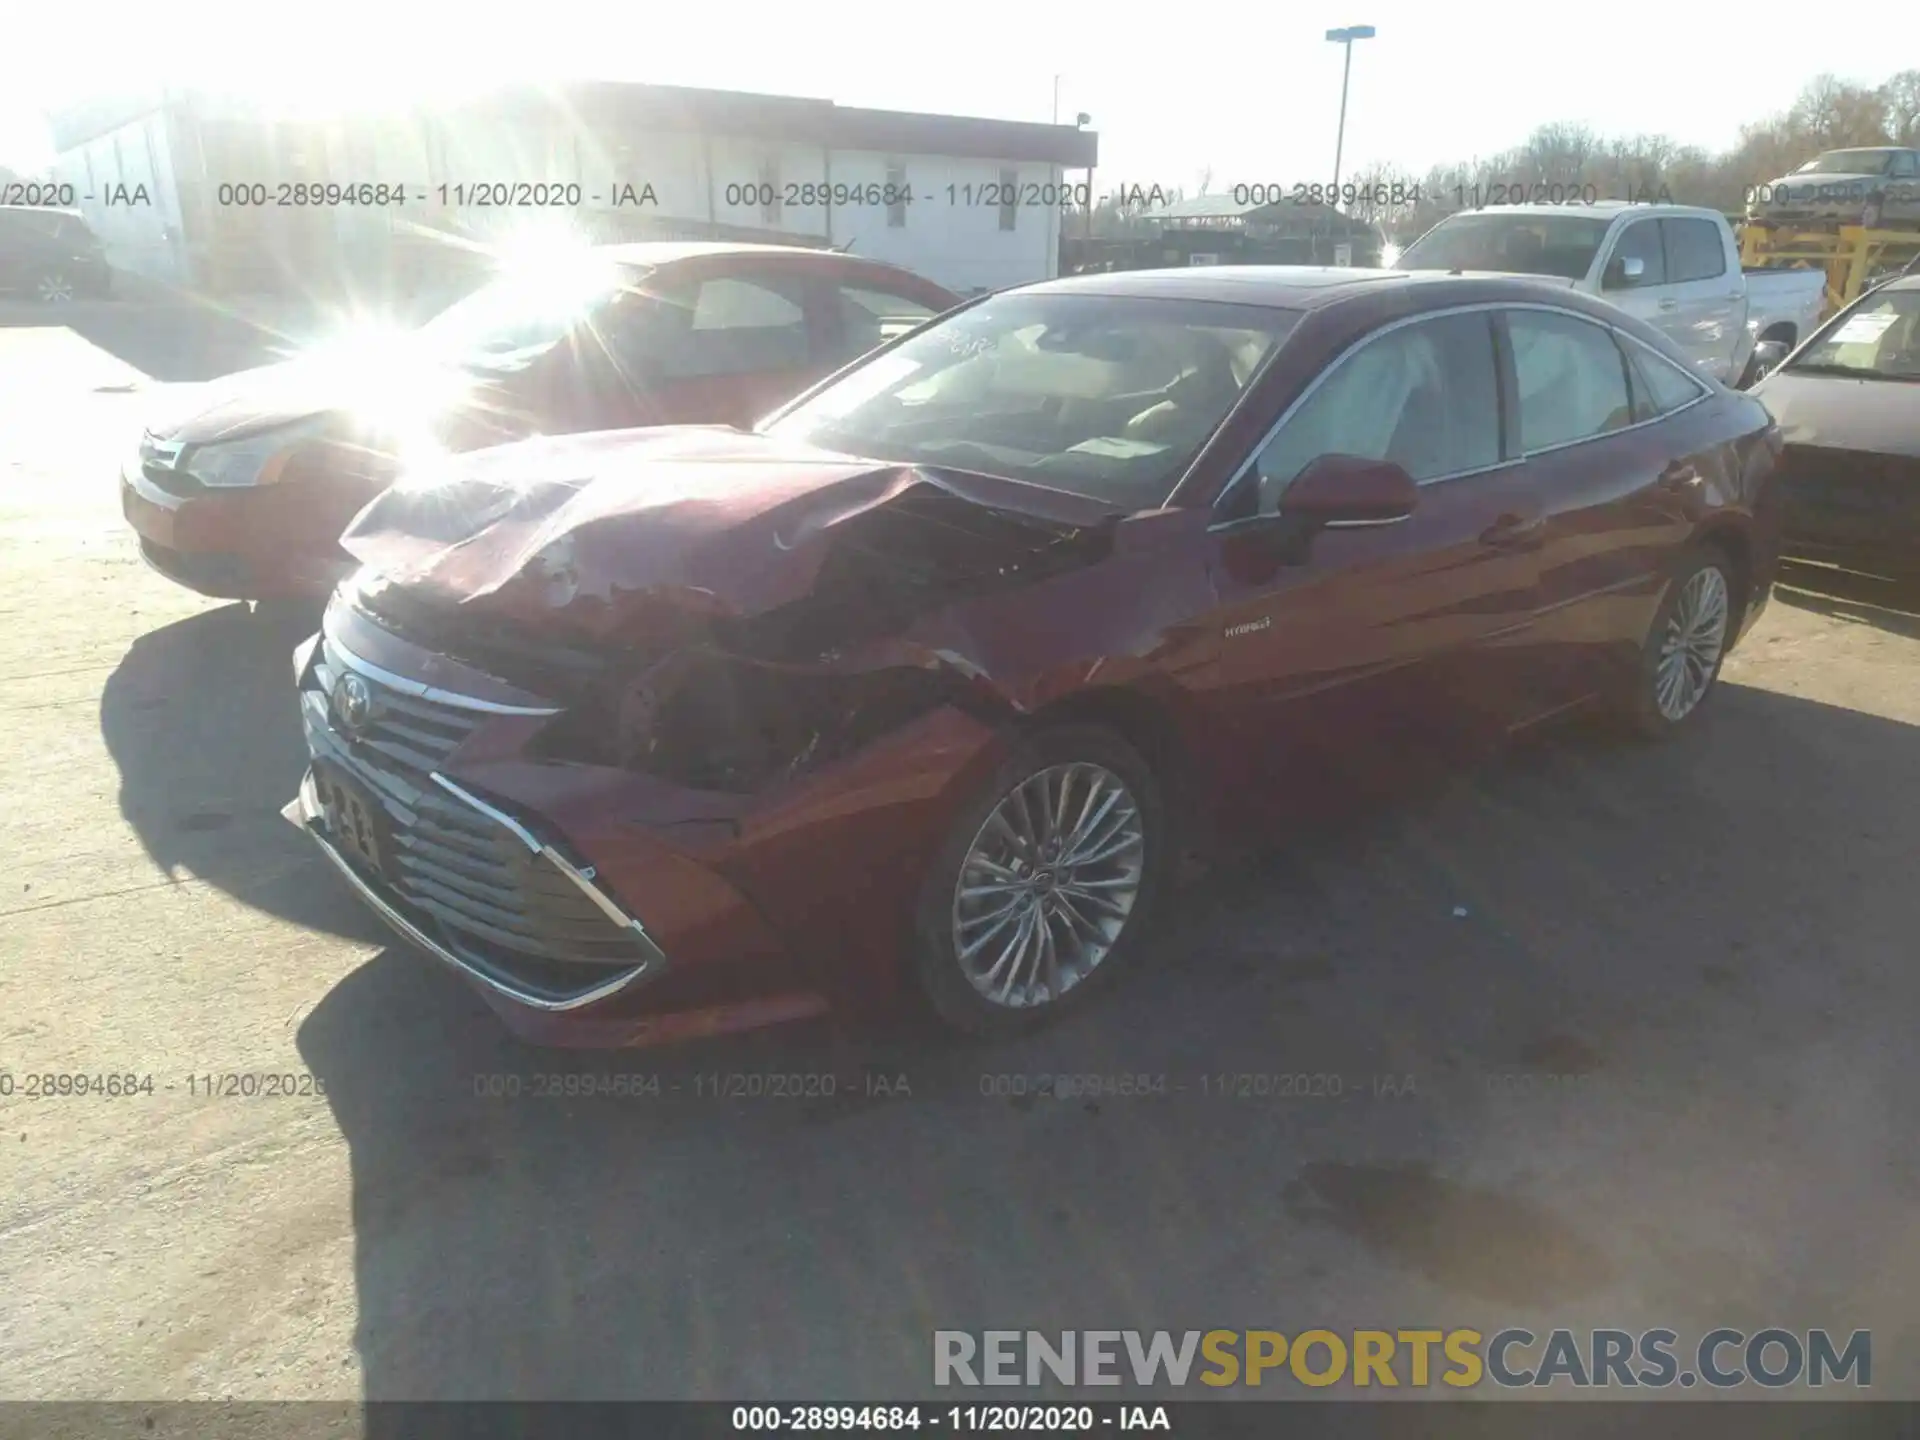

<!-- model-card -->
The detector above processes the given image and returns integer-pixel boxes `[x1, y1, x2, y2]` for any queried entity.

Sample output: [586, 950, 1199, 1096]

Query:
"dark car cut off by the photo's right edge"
[1751, 275, 1920, 576]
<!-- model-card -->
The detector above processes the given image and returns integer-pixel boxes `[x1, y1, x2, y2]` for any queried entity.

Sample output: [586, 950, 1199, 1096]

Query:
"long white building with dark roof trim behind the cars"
[41, 83, 1098, 301]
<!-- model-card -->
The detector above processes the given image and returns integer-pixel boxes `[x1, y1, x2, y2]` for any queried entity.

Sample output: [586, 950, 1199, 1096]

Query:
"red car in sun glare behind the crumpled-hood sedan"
[121, 244, 958, 599]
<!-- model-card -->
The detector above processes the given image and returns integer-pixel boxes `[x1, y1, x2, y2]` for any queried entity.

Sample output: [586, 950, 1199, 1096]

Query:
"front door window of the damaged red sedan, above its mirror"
[1254, 311, 1500, 515]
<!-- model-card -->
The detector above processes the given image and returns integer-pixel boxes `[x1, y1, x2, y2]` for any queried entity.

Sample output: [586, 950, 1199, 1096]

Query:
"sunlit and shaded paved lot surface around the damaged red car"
[0, 305, 1920, 1400]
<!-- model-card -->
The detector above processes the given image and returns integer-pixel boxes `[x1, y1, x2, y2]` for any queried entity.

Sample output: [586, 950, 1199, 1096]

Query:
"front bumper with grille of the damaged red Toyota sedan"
[284, 591, 998, 1046]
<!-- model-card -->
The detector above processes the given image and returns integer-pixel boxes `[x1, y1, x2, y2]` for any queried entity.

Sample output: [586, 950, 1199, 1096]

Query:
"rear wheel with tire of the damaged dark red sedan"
[1620, 545, 1745, 741]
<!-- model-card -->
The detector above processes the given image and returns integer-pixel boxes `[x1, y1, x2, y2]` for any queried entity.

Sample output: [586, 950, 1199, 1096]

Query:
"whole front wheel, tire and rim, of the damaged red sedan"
[912, 724, 1175, 1039]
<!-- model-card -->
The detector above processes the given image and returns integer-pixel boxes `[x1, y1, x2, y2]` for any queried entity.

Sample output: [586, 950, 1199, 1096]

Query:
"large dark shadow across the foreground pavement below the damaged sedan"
[298, 685, 1920, 1405]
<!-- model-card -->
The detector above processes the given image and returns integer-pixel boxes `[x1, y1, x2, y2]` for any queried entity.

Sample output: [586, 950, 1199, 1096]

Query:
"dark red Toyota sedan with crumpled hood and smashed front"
[288, 269, 1780, 1044]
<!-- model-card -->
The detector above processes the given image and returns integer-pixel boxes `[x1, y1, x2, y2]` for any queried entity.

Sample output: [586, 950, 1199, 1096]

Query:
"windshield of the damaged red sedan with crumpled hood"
[766, 292, 1300, 511]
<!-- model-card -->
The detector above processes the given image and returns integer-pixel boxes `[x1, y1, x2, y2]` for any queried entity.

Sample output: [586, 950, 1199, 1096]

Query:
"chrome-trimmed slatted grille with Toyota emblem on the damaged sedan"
[300, 639, 653, 979]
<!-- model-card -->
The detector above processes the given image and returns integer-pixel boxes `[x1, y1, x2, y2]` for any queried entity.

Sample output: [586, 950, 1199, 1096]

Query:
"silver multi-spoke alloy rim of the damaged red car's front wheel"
[952, 762, 1146, 1008]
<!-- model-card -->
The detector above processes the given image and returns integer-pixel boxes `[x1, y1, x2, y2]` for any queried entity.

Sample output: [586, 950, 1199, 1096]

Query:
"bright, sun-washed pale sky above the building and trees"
[0, 0, 1920, 194]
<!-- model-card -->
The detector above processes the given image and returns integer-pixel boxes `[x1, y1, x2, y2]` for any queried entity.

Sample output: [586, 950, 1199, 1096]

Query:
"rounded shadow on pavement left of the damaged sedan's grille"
[100, 603, 388, 941]
